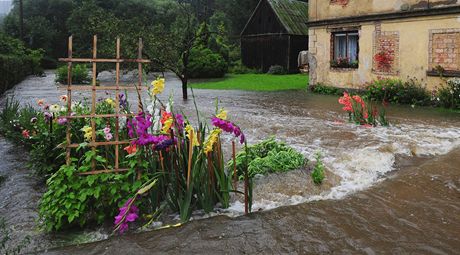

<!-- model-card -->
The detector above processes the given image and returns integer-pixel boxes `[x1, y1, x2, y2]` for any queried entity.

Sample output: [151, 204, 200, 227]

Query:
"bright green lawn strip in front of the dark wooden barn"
[191, 74, 308, 91]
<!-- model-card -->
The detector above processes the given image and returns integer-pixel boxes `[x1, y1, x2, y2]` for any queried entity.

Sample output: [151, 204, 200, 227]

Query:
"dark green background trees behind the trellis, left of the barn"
[2, 0, 258, 98]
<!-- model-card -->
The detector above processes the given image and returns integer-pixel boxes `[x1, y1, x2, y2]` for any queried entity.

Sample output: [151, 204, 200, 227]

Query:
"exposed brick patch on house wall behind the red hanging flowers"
[372, 28, 399, 75]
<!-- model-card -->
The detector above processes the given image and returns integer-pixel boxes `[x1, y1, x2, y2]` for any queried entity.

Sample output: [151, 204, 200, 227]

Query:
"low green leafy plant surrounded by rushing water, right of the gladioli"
[227, 137, 307, 178]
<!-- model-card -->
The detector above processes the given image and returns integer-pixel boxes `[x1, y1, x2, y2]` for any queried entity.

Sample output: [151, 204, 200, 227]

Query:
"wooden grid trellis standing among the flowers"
[59, 35, 150, 175]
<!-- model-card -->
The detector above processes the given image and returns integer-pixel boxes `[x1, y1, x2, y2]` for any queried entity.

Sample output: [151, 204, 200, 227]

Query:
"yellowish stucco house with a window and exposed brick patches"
[307, 0, 460, 89]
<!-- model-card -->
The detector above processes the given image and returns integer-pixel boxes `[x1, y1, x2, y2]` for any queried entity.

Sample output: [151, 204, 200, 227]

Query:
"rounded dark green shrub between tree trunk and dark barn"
[188, 47, 228, 78]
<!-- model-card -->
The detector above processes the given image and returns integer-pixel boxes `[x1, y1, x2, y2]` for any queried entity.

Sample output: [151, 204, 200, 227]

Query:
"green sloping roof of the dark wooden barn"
[262, 0, 308, 35]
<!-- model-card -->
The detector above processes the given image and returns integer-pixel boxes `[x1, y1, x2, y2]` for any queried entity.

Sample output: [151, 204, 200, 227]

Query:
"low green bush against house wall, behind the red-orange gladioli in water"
[365, 78, 430, 105]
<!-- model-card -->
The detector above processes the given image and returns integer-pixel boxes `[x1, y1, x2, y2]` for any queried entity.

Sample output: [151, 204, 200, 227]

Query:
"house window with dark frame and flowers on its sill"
[331, 31, 359, 68]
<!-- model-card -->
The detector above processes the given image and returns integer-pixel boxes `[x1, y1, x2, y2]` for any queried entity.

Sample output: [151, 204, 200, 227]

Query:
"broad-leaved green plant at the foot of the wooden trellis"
[39, 159, 142, 231]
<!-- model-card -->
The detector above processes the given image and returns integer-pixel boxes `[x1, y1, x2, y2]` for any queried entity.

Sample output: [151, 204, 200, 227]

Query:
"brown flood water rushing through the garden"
[0, 70, 460, 254]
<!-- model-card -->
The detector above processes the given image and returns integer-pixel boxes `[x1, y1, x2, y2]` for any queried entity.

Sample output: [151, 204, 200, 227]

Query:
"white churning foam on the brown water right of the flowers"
[225, 121, 460, 216]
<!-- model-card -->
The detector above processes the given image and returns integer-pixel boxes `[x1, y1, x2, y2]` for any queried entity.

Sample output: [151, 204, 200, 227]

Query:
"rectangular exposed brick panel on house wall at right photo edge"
[429, 29, 460, 71]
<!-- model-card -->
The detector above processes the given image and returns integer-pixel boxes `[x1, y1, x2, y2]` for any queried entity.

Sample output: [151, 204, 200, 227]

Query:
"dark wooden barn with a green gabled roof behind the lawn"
[241, 0, 308, 72]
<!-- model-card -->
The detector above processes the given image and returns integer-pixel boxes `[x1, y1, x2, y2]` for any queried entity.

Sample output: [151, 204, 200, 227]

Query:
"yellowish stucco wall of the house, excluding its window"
[309, 0, 460, 90]
